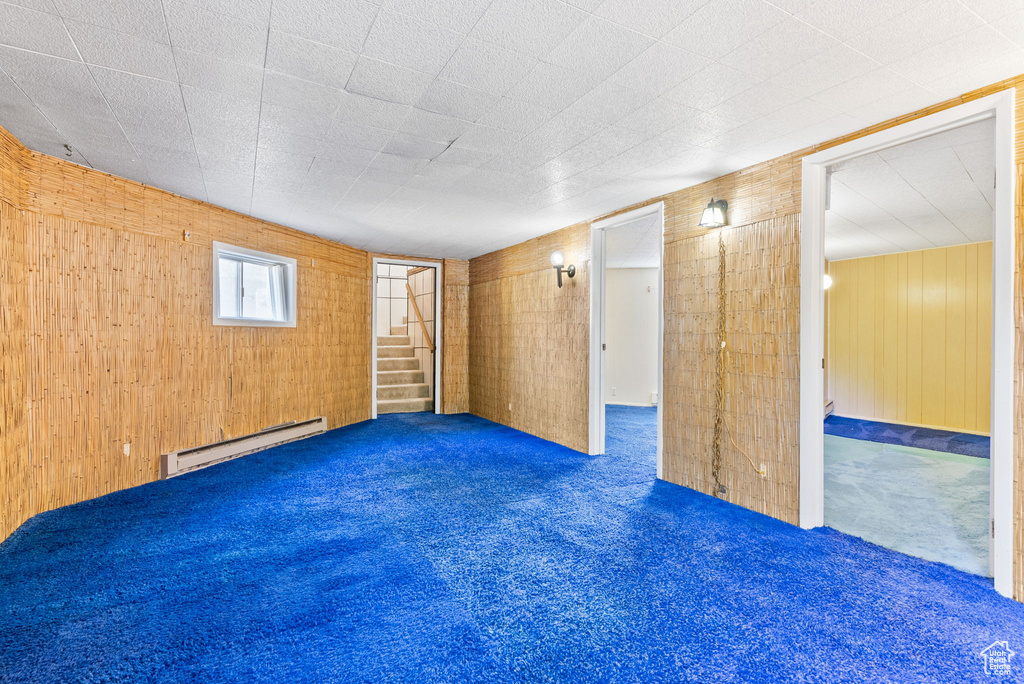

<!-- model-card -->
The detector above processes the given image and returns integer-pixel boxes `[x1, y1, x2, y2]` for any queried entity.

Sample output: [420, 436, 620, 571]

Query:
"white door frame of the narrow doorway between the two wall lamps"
[590, 202, 665, 478]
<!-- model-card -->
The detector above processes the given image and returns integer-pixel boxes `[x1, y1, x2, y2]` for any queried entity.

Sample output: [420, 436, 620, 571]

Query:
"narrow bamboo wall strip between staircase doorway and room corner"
[441, 259, 469, 414]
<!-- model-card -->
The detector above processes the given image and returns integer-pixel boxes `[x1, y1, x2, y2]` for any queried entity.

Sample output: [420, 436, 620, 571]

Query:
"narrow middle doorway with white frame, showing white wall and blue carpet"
[590, 203, 665, 477]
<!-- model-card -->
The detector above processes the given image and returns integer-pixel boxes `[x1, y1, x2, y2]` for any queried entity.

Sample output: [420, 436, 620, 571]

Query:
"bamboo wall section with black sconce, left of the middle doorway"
[469, 224, 590, 452]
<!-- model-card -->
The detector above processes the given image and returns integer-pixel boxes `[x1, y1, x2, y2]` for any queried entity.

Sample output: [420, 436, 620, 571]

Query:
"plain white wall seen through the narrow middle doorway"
[604, 268, 660, 407]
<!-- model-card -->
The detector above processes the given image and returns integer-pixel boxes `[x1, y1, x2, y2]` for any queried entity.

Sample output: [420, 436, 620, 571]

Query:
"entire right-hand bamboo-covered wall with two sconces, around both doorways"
[470, 76, 1024, 600]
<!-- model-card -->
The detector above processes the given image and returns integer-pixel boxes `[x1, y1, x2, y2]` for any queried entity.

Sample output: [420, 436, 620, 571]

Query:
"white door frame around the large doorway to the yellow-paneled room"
[800, 88, 1016, 596]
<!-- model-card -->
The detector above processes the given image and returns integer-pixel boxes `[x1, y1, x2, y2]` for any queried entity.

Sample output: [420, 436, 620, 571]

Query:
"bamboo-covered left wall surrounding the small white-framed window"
[0, 129, 371, 539]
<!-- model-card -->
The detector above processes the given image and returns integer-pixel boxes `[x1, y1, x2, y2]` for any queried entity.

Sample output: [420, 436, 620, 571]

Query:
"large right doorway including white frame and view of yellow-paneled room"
[800, 90, 1014, 596]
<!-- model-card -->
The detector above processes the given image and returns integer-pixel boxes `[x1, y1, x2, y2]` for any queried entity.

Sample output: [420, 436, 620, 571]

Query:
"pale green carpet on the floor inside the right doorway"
[825, 434, 990, 576]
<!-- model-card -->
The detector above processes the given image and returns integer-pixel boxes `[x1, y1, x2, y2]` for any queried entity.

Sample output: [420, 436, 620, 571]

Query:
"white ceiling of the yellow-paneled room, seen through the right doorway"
[825, 119, 995, 260]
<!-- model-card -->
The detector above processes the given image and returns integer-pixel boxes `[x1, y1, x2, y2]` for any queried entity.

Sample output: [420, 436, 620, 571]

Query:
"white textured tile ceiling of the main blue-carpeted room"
[0, 0, 1024, 257]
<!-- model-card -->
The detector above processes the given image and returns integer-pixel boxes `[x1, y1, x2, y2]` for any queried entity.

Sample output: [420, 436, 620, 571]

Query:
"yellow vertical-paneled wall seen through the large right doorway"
[826, 242, 992, 434]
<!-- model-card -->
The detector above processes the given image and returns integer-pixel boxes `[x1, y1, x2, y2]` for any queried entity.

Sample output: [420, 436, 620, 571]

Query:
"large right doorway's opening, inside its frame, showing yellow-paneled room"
[824, 119, 995, 576]
